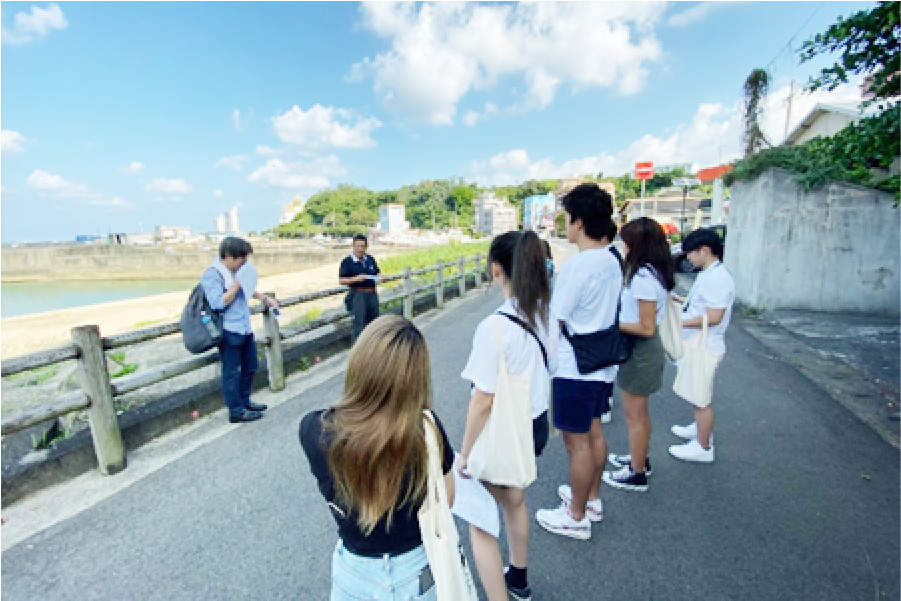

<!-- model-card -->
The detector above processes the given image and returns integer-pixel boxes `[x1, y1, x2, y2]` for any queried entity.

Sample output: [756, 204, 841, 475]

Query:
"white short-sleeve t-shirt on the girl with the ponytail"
[460, 299, 555, 419]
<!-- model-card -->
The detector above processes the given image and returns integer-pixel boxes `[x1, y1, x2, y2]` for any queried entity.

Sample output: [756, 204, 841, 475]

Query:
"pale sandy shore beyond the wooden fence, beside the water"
[0, 263, 341, 359]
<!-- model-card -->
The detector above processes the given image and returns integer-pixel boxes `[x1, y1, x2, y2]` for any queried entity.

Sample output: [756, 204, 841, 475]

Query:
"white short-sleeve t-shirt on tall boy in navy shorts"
[551, 247, 623, 382]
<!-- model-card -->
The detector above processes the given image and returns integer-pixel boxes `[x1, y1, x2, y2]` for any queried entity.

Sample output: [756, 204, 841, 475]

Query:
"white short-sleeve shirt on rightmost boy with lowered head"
[682, 261, 735, 355]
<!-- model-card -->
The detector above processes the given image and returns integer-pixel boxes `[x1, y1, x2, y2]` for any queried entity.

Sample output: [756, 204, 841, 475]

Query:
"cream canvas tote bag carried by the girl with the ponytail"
[466, 320, 538, 488]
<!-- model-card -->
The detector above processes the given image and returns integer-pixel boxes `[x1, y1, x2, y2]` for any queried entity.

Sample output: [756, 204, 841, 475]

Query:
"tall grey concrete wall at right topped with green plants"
[725, 169, 901, 315]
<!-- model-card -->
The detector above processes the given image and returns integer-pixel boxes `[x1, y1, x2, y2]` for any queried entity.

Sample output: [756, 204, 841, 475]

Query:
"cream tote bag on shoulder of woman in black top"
[417, 411, 478, 601]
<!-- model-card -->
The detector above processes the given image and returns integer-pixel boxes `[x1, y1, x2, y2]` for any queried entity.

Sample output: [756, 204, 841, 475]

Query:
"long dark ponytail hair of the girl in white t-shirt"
[488, 232, 551, 328]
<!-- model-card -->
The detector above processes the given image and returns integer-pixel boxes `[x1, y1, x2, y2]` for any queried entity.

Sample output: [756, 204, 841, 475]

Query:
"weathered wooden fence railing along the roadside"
[0, 254, 484, 475]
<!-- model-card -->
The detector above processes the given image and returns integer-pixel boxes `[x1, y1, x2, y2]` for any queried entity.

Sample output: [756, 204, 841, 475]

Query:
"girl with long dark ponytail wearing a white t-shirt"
[456, 232, 554, 601]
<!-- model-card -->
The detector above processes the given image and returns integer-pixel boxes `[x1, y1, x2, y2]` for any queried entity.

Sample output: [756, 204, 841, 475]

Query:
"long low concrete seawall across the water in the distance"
[0, 245, 349, 282]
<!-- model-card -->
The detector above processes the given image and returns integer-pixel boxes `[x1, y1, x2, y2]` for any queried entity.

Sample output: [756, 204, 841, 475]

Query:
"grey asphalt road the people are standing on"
[2, 284, 899, 601]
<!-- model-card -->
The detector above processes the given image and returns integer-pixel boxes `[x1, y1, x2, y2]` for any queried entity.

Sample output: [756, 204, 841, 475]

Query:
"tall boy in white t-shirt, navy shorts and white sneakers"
[535, 184, 623, 540]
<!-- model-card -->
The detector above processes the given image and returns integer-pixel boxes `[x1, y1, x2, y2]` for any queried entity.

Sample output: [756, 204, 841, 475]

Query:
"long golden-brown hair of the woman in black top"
[324, 315, 431, 534]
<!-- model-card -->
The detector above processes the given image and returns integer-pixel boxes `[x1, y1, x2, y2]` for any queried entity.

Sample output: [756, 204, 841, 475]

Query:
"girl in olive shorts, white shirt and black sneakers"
[602, 217, 676, 491]
